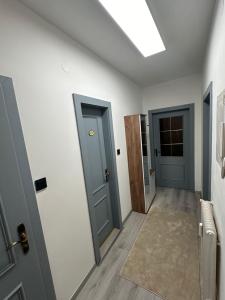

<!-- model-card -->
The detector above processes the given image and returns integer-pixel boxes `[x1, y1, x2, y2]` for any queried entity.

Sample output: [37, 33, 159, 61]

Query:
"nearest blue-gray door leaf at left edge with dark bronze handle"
[0, 76, 51, 300]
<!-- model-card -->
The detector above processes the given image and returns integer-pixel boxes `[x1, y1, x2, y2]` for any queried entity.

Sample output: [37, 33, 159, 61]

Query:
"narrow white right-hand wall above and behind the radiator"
[203, 0, 225, 300]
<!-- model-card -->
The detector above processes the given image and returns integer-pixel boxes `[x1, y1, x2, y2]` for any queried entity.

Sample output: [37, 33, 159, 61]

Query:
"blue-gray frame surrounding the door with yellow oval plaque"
[73, 94, 123, 264]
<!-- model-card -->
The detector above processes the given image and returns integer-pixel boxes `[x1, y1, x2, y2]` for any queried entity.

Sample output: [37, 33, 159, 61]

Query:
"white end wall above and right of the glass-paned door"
[143, 74, 202, 191]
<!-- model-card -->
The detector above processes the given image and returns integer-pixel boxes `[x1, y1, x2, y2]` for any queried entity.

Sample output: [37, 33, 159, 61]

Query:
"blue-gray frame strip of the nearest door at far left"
[0, 75, 56, 300]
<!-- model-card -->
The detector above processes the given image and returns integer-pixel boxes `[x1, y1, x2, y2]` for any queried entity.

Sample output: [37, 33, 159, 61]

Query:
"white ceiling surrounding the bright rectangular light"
[21, 0, 216, 86]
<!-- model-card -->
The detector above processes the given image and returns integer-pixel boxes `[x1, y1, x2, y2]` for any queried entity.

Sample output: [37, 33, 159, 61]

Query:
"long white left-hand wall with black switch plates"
[0, 0, 141, 300]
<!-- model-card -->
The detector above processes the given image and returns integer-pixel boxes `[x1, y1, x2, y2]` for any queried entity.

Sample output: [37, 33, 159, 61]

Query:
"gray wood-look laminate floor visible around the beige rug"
[74, 188, 197, 300]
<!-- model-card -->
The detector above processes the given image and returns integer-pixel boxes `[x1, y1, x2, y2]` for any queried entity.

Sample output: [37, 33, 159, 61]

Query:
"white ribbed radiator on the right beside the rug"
[199, 200, 217, 300]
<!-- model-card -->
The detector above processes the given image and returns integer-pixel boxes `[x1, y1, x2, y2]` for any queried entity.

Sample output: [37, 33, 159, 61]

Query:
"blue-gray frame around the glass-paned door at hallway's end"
[148, 103, 195, 191]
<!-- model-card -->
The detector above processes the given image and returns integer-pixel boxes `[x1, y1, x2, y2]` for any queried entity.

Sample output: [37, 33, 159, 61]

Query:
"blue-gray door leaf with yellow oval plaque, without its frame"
[82, 106, 113, 245]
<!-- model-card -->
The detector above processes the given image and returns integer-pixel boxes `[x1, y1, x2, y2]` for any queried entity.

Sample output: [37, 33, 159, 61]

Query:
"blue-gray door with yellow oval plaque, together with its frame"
[73, 94, 123, 264]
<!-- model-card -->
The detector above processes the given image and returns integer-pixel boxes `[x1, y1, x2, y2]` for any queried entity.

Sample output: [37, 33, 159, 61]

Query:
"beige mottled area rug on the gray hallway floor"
[120, 208, 200, 300]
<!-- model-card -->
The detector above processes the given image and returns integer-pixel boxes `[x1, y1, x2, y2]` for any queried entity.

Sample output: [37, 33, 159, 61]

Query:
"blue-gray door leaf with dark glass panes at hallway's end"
[153, 110, 193, 189]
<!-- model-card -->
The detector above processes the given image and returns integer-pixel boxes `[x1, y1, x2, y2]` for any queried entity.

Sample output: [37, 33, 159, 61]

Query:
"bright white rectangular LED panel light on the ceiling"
[99, 0, 166, 57]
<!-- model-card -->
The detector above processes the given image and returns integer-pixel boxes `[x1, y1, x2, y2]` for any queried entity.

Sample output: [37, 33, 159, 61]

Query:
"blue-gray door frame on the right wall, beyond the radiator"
[202, 82, 213, 200]
